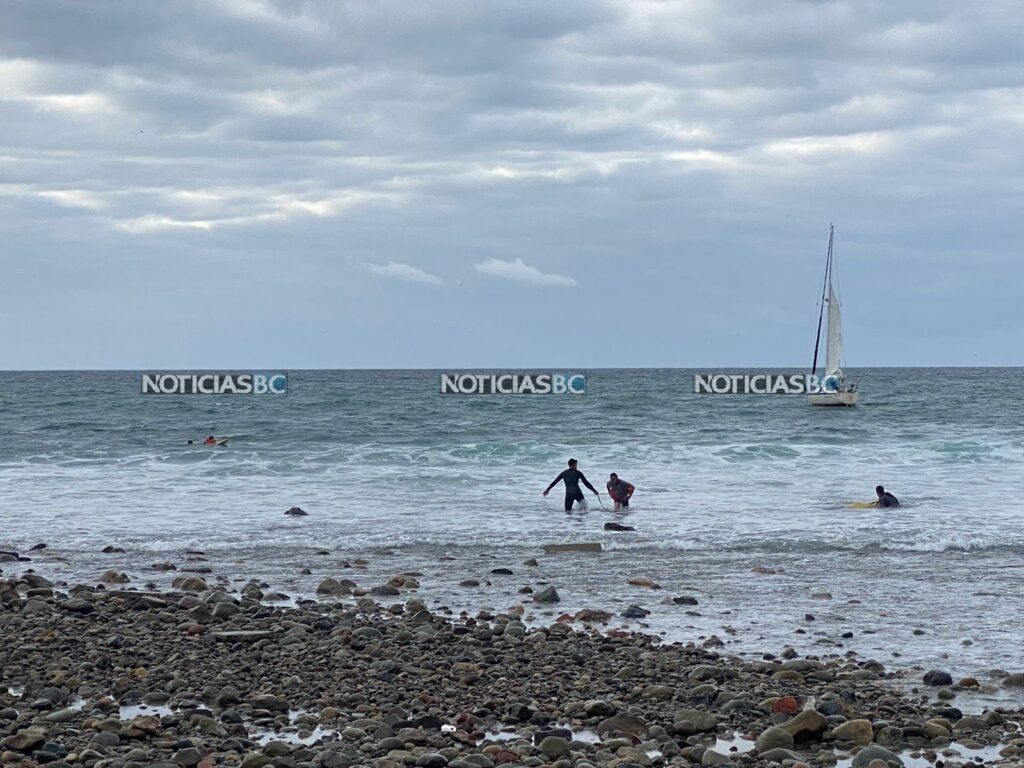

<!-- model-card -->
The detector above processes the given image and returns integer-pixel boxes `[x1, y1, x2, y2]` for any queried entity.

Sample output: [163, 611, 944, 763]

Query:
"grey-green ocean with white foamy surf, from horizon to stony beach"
[0, 369, 1024, 678]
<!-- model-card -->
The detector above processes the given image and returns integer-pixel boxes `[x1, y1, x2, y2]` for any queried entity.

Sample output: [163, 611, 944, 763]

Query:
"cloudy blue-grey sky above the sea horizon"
[0, 0, 1024, 370]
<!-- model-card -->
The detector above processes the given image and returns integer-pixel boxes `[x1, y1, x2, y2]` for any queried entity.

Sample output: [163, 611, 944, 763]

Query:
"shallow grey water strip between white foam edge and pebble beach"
[0, 540, 1024, 679]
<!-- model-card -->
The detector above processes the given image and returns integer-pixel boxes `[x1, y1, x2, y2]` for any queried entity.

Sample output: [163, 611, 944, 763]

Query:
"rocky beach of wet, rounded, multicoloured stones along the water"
[0, 552, 1024, 768]
